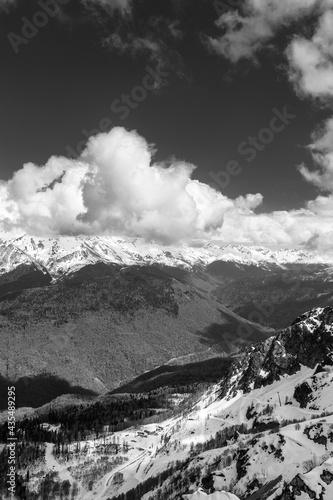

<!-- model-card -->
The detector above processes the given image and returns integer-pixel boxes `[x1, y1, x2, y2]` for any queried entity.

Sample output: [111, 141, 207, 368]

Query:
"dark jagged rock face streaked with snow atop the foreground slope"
[222, 307, 333, 400]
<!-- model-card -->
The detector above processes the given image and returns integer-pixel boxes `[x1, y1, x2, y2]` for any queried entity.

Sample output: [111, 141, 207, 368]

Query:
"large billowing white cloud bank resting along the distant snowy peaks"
[0, 127, 333, 250]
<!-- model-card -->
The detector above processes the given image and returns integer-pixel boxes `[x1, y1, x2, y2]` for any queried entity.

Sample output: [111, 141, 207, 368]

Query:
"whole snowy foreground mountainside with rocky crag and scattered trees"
[9, 307, 333, 500]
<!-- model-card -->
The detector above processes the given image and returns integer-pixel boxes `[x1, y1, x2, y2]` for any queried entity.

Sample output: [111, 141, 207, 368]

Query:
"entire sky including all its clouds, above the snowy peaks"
[0, 0, 333, 250]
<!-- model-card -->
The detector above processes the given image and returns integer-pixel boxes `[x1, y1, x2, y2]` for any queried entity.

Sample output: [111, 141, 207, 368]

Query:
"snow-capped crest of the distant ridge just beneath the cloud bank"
[0, 236, 333, 278]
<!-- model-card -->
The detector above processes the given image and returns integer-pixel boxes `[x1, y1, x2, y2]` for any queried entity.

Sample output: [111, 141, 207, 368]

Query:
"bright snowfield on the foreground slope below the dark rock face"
[30, 367, 333, 500]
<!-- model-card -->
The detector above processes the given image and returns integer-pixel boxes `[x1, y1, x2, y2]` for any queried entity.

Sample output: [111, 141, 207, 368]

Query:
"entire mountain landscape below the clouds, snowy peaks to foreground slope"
[0, 238, 333, 500]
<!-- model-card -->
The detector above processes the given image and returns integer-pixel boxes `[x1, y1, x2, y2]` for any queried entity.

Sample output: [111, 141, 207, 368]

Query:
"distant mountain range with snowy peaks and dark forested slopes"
[0, 236, 333, 398]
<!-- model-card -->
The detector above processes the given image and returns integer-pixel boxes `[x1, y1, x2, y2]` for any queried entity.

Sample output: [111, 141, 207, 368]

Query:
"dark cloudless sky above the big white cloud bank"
[0, 0, 325, 211]
